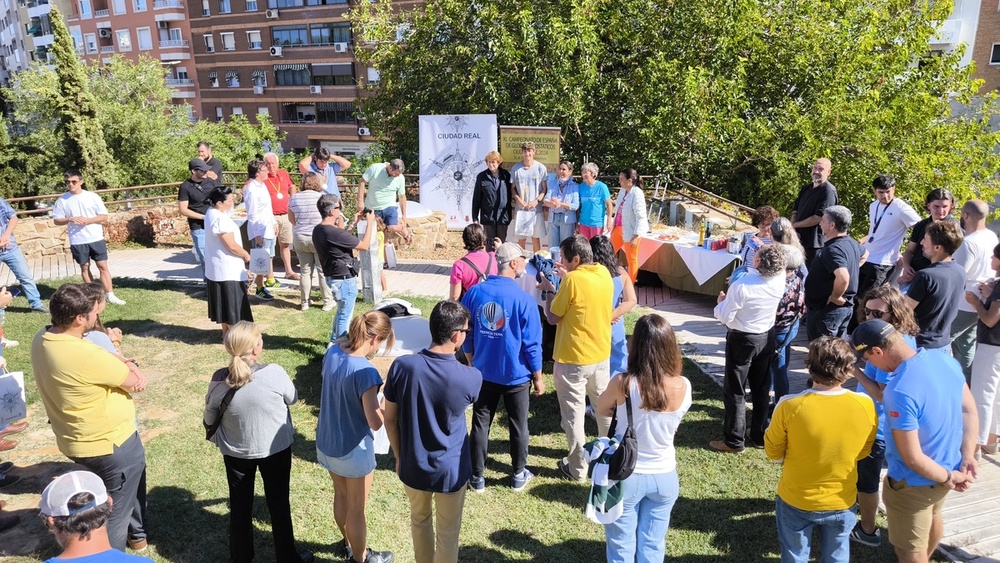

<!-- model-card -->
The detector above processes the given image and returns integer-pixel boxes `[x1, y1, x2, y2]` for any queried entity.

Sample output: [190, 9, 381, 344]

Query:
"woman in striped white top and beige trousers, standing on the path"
[288, 172, 337, 311]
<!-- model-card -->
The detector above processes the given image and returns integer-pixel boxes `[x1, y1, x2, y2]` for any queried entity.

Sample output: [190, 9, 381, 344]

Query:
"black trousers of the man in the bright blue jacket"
[471, 380, 531, 475]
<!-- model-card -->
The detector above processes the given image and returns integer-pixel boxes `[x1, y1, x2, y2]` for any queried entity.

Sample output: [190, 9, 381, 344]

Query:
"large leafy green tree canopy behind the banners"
[351, 0, 1000, 221]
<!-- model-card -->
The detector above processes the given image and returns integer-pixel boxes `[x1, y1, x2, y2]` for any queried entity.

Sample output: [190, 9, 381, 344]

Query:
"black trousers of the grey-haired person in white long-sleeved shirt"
[722, 330, 774, 449]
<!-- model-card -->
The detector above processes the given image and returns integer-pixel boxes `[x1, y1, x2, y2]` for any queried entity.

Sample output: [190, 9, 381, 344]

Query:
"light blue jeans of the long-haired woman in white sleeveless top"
[604, 471, 680, 563]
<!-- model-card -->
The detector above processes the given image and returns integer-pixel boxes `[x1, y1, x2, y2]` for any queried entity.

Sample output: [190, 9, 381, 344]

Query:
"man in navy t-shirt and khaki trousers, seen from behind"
[384, 301, 483, 563]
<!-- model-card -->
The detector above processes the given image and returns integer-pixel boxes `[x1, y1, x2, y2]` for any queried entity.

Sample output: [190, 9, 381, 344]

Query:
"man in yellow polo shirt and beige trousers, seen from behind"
[539, 235, 614, 481]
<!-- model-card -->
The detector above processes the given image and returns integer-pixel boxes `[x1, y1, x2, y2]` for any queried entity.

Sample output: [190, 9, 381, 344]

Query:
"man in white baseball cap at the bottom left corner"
[39, 471, 152, 563]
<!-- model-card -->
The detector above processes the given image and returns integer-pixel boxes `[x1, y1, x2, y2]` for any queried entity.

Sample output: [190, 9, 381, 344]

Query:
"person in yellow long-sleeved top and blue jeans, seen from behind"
[764, 338, 876, 563]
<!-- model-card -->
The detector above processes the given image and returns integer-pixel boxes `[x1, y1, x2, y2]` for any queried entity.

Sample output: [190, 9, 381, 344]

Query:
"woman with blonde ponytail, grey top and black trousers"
[204, 321, 313, 563]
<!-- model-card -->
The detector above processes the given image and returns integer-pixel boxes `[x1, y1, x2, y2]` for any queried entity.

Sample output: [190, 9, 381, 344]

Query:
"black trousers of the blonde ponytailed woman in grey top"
[222, 447, 302, 563]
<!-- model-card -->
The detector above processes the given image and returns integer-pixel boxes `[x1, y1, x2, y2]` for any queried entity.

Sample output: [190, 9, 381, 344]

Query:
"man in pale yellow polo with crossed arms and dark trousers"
[31, 283, 146, 551]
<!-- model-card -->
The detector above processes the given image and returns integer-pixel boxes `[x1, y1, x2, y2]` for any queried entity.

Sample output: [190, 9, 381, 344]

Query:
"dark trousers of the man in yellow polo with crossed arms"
[70, 432, 146, 551]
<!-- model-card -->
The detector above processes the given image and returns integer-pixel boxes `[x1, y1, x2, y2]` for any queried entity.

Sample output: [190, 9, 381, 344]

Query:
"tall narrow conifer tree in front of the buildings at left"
[49, 6, 120, 188]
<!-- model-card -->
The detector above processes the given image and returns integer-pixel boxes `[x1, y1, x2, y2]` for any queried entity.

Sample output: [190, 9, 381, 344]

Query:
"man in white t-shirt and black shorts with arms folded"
[52, 169, 125, 305]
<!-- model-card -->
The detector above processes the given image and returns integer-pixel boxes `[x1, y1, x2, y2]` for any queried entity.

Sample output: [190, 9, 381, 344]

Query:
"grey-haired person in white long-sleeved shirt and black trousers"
[708, 244, 785, 453]
